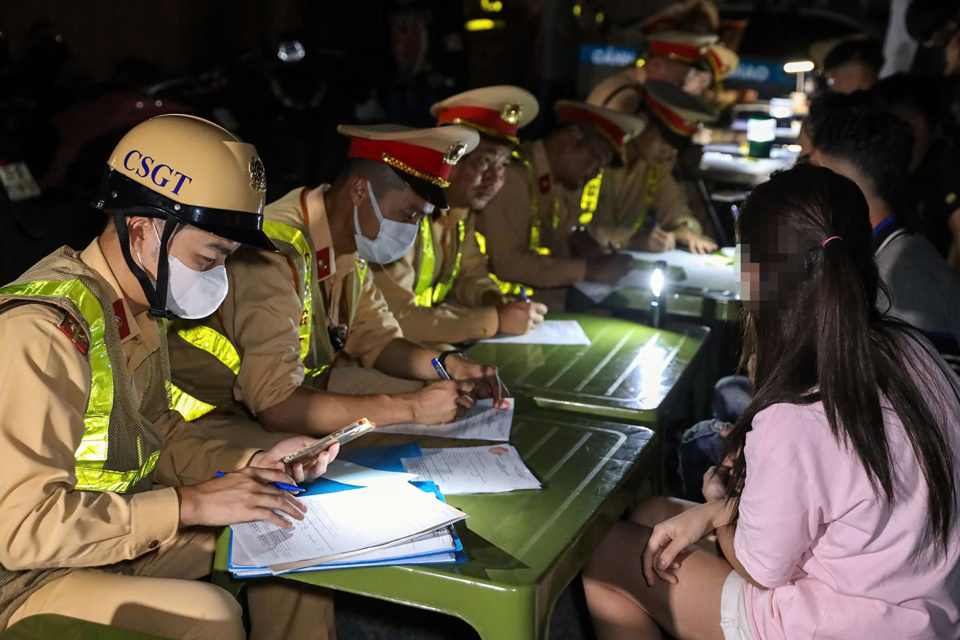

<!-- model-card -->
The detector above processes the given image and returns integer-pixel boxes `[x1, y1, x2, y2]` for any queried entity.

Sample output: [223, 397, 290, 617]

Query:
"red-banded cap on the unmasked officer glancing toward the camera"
[430, 85, 540, 145]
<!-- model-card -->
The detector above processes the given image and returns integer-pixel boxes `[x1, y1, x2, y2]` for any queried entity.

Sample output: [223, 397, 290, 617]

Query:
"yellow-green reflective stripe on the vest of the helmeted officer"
[0, 280, 163, 493]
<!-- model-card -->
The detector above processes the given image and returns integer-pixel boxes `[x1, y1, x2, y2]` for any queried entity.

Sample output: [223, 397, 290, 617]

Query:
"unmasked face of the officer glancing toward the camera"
[447, 138, 510, 211]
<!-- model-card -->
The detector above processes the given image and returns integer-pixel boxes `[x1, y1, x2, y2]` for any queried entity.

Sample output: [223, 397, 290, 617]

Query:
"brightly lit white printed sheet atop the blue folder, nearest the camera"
[230, 482, 467, 570]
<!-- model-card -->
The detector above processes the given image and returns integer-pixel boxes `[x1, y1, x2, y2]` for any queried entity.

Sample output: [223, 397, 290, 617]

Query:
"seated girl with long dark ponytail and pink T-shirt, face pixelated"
[583, 165, 960, 640]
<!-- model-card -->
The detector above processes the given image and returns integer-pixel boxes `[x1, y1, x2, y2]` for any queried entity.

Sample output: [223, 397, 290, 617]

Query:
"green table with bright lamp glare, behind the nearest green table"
[467, 313, 710, 429]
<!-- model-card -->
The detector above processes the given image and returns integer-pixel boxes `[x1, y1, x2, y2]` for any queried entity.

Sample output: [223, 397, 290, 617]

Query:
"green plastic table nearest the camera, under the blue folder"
[214, 409, 658, 640]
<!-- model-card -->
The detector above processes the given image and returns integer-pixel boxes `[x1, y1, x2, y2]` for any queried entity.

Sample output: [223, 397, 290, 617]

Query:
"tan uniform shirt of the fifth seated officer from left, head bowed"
[588, 160, 702, 248]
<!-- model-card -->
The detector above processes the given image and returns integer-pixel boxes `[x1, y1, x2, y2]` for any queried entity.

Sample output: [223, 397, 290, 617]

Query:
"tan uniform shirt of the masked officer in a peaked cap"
[170, 187, 403, 414]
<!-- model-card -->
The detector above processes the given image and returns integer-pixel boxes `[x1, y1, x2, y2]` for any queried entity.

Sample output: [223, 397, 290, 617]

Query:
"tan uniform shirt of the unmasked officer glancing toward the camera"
[371, 209, 504, 344]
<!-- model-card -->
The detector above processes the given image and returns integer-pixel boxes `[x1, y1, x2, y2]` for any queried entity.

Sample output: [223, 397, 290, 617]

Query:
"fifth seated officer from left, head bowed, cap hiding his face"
[587, 80, 717, 253]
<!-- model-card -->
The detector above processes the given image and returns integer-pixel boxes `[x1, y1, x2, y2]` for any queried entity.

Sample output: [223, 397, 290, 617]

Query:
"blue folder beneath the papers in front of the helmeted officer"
[227, 443, 467, 578]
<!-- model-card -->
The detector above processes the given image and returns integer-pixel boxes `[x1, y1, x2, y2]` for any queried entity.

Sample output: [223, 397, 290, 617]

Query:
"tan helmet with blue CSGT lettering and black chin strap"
[94, 114, 276, 318]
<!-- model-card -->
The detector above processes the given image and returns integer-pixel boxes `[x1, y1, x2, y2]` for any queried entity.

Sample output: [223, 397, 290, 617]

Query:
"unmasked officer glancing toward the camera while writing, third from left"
[373, 86, 546, 344]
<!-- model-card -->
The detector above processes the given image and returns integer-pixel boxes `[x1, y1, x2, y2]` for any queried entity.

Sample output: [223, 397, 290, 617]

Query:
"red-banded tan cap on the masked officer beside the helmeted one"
[337, 124, 480, 209]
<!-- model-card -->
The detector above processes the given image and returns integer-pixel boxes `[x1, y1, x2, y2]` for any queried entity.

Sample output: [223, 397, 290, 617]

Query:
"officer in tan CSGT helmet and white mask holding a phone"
[0, 115, 337, 639]
